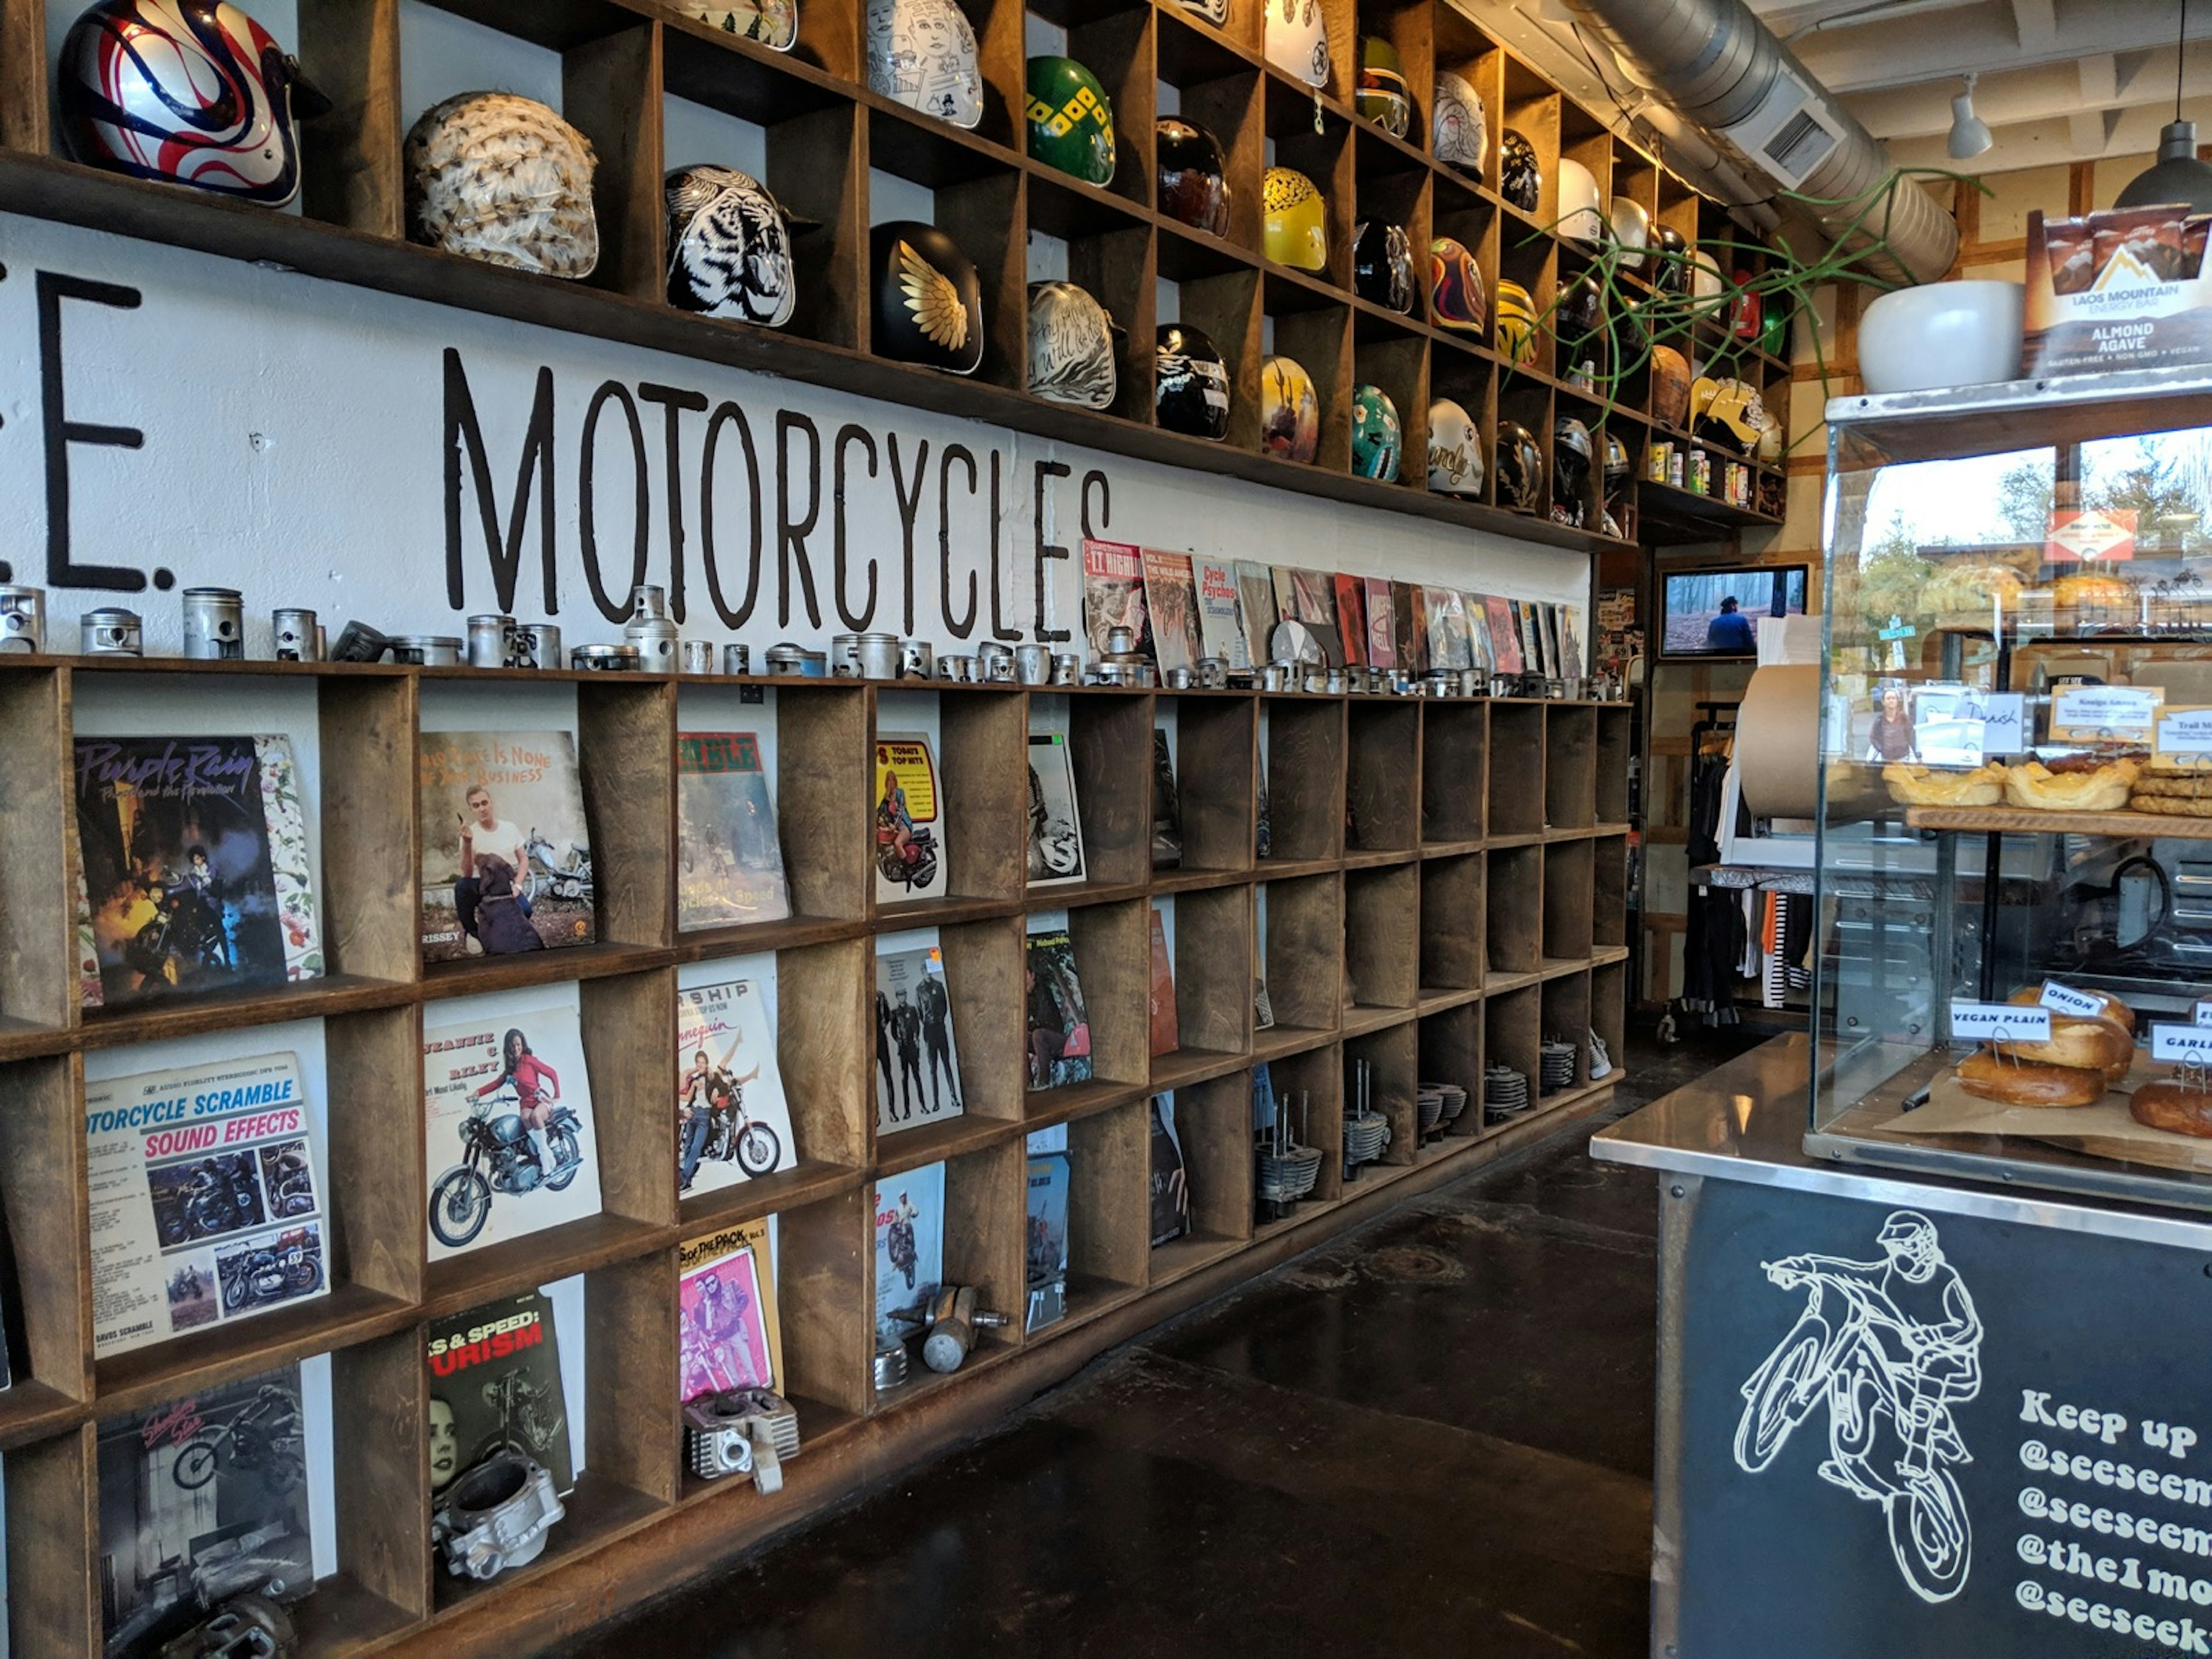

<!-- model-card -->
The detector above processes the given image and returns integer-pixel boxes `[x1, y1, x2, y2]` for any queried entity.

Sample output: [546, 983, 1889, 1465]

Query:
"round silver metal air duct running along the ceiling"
[1566, 0, 1957, 283]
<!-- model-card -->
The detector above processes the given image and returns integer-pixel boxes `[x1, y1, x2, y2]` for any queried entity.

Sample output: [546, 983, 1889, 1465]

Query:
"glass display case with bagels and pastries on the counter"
[1798, 369, 2212, 1208]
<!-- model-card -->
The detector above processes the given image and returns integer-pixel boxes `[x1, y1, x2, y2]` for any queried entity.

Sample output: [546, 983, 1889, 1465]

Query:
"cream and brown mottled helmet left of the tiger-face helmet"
[403, 93, 600, 279]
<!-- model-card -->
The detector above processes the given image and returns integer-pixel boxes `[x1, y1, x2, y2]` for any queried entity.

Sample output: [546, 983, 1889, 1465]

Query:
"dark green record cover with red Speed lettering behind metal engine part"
[422, 1290, 575, 1495]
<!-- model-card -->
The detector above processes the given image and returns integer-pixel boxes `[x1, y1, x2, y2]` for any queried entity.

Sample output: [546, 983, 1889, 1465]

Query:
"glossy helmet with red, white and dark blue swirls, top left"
[60, 0, 329, 208]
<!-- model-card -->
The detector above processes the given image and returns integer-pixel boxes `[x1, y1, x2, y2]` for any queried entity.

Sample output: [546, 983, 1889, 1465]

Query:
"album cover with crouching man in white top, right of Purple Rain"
[418, 732, 597, 962]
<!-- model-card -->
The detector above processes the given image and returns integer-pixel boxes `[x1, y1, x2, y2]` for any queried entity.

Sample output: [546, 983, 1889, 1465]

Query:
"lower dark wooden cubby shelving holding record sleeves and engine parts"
[0, 657, 1630, 1659]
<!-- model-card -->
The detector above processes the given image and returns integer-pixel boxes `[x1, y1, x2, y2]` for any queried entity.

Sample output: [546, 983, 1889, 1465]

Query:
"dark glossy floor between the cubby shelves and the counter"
[557, 1033, 1749, 1659]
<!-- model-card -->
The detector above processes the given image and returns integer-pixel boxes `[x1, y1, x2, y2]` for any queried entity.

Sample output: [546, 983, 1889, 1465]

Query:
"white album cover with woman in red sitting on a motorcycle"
[422, 1004, 600, 1261]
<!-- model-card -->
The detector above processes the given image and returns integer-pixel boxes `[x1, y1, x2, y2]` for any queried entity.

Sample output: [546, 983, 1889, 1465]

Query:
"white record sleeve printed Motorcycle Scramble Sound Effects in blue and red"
[84, 1053, 329, 1358]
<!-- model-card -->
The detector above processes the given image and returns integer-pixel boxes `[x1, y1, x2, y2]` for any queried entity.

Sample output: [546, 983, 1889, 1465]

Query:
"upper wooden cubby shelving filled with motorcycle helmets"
[0, 0, 1790, 551]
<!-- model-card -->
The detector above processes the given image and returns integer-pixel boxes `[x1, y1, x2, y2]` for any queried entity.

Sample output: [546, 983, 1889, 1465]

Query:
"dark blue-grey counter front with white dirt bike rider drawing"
[1679, 1181, 2212, 1659]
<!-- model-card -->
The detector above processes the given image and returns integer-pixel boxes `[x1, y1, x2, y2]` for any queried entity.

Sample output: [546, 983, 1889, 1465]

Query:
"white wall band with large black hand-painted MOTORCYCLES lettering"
[0, 214, 1588, 655]
